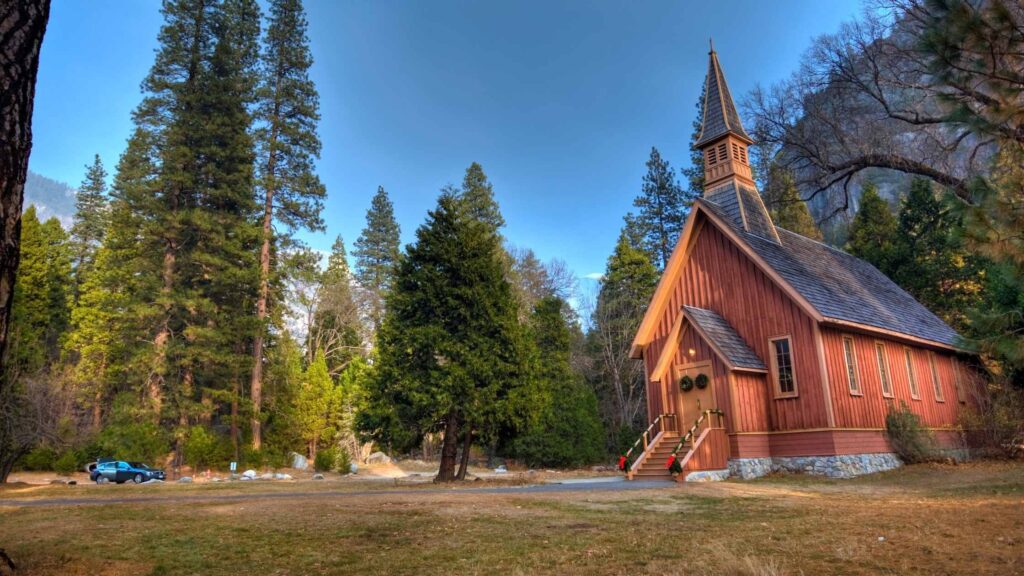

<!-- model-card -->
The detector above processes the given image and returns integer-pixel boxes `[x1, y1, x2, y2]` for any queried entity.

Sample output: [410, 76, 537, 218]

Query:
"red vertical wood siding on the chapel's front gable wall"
[643, 216, 828, 431]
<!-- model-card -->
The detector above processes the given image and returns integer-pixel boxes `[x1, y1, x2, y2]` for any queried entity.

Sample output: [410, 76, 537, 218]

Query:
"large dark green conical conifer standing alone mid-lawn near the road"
[360, 194, 522, 482]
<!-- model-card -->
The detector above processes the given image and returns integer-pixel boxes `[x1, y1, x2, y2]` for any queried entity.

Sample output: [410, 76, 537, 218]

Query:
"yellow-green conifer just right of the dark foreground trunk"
[7, 206, 72, 373]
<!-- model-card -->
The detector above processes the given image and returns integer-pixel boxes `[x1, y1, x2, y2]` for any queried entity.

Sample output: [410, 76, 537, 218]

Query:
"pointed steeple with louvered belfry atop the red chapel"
[693, 46, 754, 191]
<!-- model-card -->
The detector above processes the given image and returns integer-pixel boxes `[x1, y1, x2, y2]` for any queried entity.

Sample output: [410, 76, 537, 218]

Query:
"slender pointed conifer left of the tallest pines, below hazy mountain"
[71, 154, 109, 289]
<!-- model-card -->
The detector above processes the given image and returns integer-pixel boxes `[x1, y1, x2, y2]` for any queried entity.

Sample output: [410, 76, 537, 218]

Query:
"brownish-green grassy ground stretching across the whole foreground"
[0, 462, 1024, 575]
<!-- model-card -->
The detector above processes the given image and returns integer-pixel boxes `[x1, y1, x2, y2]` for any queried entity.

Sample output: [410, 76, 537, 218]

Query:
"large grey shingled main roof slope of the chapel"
[696, 192, 958, 346]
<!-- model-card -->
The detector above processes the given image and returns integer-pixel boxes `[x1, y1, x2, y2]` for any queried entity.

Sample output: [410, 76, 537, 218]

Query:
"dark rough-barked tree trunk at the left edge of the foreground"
[0, 0, 50, 387]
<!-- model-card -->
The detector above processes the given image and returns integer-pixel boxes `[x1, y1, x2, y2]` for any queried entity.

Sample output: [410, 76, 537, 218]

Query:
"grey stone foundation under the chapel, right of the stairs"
[729, 452, 903, 480]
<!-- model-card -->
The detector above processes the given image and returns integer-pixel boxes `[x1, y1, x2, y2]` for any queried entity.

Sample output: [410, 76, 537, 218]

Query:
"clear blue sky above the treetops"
[30, 0, 860, 277]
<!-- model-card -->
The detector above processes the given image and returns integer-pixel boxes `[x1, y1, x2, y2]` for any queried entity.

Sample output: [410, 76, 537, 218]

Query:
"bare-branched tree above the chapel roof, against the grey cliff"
[746, 0, 1024, 211]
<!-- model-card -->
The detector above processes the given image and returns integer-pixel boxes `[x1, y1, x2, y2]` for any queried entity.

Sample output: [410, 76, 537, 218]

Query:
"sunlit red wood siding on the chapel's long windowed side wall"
[821, 328, 973, 428]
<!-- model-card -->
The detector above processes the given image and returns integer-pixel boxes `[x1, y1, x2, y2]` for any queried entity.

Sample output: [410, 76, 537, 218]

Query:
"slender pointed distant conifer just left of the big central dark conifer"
[353, 187, 401, 332]
